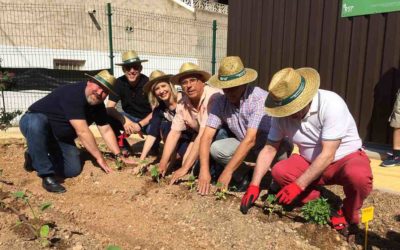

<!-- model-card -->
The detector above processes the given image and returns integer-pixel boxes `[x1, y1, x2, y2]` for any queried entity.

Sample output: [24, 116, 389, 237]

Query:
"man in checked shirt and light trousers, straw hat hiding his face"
[198, 56, 290, 195]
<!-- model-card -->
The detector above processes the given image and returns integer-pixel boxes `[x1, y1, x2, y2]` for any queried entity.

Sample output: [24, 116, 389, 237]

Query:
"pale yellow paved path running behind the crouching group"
[0, 126, 400, 193]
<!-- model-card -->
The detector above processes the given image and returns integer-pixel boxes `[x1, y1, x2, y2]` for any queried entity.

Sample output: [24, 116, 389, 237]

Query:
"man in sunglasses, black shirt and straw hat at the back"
[107, 50, 153, 154]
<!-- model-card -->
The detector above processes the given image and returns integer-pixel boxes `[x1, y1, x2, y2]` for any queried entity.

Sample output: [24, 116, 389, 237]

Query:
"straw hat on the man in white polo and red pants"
[265, 68, 320, 117]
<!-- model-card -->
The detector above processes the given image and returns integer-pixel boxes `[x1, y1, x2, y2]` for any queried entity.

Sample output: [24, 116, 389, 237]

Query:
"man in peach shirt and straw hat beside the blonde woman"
[159, 62, 220, 181]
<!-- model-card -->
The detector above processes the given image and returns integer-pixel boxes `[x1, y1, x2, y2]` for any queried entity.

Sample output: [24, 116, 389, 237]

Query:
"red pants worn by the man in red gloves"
[272, 150, 372, 223]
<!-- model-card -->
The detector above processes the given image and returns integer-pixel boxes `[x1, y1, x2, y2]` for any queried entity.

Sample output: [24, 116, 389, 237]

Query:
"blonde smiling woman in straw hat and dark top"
[140, 70, 191, 167]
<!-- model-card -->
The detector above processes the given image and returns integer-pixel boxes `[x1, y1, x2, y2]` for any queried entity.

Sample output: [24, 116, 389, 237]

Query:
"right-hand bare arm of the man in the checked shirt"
[218, 128, 258, 188]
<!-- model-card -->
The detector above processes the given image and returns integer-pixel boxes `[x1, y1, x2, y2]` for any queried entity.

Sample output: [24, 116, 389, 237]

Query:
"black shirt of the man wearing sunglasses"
[109, 74, 151, 119]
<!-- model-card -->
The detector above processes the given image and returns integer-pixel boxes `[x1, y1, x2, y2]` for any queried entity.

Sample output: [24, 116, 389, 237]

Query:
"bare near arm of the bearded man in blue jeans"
[69, 119, 111, 173]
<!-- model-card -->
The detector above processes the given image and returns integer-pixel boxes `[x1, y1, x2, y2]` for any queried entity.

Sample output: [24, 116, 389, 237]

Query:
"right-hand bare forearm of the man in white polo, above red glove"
[296, 140, 341, 190]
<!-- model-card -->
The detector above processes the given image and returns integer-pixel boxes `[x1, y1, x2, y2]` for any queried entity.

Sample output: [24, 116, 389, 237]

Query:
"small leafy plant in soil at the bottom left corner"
[14, 191, 52, 247]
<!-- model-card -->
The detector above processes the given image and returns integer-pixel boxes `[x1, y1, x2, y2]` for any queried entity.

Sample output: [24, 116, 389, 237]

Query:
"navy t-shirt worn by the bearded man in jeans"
[28, 82, 108, 141]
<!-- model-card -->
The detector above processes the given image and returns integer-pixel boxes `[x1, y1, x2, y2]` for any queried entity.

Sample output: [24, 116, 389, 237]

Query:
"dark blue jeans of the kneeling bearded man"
[19, 112, 82, 177]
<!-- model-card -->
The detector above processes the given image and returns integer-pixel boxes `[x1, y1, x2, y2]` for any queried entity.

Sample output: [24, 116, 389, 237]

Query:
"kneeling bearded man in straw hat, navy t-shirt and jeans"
[19, 70, 132, 193]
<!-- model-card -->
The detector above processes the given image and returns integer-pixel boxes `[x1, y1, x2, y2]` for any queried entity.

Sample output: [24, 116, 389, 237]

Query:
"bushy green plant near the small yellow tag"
[301, 198, 331, 225]
